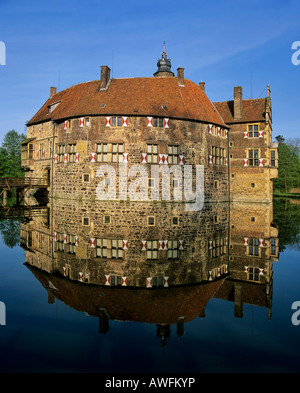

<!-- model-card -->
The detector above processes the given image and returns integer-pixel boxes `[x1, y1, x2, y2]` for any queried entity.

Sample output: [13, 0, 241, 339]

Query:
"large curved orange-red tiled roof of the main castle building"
[27, 77, 225, 126]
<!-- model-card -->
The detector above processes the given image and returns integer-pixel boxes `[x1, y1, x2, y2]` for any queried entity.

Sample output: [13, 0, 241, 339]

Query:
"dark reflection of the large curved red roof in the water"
[26, 264, 224, 324]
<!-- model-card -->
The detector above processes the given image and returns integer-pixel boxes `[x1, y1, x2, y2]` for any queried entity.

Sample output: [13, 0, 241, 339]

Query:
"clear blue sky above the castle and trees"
[0, 0, 300, 143]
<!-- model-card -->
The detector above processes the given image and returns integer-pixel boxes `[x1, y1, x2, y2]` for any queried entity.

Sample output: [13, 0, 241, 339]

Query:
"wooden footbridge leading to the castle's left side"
[0, 177, 49, 206]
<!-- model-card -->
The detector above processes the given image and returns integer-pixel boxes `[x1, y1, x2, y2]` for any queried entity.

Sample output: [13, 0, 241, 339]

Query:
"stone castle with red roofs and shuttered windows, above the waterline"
[22, 50, 278, 202]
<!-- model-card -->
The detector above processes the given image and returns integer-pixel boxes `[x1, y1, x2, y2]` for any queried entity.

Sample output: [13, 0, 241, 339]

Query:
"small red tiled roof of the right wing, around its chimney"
[214, 98, 266, 124]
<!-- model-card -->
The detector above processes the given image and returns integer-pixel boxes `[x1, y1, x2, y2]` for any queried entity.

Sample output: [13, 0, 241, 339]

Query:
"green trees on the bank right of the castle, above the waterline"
[274, 135, 300, 192]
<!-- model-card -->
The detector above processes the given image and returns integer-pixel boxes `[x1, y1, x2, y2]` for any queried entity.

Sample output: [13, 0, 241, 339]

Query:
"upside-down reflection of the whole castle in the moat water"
[21, 200, 279, 339]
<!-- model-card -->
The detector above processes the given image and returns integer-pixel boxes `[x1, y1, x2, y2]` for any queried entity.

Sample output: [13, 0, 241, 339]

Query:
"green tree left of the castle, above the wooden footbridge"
[0, 130, 26, 177]
